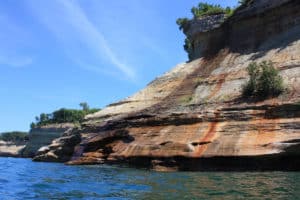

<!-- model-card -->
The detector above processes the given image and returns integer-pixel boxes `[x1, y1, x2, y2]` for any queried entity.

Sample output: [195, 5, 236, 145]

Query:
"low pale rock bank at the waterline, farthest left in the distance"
[0, 140, 26, 157]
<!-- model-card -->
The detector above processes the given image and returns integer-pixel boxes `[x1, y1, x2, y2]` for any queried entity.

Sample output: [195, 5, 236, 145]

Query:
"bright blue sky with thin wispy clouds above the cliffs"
[0, 0, 237, 132]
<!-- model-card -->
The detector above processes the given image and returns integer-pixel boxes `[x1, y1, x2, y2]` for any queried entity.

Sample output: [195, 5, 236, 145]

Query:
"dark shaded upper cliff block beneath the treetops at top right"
[186, 0, 299, 59]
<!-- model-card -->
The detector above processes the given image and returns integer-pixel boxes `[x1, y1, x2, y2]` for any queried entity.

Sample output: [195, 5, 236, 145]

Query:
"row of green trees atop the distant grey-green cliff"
[30, 102, 100, 128]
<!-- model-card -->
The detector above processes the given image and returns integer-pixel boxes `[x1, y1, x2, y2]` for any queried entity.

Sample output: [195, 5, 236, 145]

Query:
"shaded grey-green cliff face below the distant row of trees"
[22, 124, 74, 158]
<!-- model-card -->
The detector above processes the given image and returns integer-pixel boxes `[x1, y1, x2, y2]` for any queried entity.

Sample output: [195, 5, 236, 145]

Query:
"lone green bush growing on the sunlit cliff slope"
[242, 61, 284, 98]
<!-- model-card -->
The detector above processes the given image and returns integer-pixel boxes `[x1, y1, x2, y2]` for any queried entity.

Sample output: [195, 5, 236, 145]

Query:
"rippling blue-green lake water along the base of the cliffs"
[0, 158, 300, 200]
